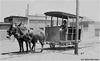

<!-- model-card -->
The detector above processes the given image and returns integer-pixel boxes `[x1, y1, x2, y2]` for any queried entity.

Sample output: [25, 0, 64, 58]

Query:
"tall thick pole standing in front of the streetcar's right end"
[74, 0, 79, 55]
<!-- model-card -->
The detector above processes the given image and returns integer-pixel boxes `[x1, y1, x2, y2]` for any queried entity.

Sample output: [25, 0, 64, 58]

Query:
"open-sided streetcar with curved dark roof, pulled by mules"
[44, 11, 83, 48]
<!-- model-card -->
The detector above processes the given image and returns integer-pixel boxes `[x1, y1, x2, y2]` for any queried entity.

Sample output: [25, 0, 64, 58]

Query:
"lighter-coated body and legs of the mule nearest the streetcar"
[29, 30, 46, 52]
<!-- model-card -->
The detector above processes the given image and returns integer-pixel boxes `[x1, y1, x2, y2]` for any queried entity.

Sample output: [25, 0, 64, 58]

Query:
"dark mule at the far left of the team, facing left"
[6, 25, 31, 52]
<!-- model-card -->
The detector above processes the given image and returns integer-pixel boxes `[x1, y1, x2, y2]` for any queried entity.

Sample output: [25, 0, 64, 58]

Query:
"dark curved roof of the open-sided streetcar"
[44, 11, 83, 19]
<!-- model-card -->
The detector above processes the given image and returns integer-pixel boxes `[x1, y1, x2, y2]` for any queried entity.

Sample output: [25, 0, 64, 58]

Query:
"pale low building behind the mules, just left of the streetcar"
[29, 15, 50, 29]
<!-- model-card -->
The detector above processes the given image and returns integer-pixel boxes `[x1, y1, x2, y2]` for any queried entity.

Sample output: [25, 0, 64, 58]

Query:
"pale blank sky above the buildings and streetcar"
[0, 0, 100, 21]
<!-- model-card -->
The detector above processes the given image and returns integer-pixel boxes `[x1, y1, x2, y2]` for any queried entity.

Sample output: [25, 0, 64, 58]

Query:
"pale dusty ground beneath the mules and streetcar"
[0, 39, 100, 61]
